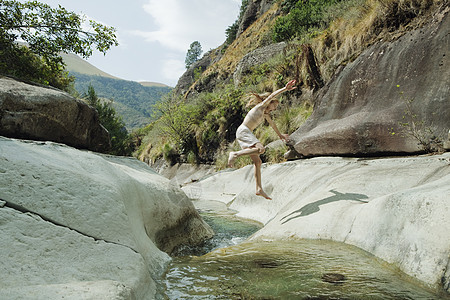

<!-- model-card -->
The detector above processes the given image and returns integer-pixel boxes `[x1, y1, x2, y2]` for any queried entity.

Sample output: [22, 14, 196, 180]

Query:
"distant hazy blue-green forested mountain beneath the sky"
[61, 54, 172, 130]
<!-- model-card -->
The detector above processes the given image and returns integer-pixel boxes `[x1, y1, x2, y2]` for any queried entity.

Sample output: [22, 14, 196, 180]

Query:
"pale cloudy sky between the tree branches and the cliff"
[34, 0, 241, 87]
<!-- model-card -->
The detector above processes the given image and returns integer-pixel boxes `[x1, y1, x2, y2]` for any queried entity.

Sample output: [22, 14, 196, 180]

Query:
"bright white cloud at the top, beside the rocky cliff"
[133, 0, 239, 53]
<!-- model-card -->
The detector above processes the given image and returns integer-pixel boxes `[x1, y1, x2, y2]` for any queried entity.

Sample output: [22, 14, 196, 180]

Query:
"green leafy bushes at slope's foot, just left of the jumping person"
[137, 86, 245, 163]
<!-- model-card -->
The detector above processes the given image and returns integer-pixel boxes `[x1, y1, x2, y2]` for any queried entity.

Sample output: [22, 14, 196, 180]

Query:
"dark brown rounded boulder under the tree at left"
[0, 76, 110, 152]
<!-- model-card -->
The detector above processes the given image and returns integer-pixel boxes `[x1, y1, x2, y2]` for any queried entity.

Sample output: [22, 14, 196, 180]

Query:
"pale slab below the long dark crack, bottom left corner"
[0, 207, 151, 299]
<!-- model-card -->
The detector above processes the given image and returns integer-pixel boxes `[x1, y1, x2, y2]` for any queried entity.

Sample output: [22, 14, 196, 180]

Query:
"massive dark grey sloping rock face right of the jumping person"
[287, 10, 450, 157]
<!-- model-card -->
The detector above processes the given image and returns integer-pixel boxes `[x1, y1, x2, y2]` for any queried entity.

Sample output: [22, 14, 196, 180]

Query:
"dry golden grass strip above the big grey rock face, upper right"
[311, 0, 448, 81]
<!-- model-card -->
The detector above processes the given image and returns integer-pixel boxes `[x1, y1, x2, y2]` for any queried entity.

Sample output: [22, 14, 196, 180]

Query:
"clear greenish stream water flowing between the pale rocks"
[165, 200, 450, 299]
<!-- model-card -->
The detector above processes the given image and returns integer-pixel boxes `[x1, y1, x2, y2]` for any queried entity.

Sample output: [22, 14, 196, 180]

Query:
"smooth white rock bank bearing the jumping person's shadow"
[190, 153, 450, 293]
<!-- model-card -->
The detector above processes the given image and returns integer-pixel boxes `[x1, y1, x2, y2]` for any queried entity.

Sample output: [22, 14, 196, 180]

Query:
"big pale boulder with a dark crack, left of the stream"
[0, 137, 213, 299]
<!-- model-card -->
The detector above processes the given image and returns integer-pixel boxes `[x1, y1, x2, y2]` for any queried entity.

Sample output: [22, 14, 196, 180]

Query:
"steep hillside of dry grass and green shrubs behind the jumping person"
[136, 0, 442, 168]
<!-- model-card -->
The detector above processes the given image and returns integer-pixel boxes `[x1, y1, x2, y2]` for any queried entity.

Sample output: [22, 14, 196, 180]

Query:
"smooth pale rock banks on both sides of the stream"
[0, 138, 450, 299]
